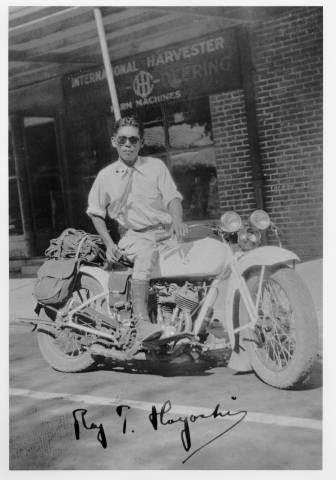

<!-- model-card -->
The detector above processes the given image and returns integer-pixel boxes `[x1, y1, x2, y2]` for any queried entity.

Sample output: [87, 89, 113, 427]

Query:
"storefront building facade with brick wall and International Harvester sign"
[9, 7, 323, 259]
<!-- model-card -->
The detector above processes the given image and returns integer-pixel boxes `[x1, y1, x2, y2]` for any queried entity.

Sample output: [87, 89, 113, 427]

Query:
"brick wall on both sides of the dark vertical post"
[210, 7, 323, 260]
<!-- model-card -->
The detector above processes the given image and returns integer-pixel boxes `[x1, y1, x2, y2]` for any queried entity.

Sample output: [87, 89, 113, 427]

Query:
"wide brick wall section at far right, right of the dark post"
[253, 7, 323, 259]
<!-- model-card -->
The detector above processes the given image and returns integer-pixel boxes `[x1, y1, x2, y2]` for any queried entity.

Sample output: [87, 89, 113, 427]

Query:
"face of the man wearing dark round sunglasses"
[112, 125, 142, 166]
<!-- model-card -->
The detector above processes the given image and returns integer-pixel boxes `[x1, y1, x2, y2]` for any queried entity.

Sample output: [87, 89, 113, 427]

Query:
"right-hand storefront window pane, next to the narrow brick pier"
[167, 97, 219, 220]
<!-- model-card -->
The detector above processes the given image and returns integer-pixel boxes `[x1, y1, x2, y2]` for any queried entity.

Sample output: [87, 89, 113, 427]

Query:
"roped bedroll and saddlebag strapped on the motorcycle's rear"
[33, 228, 105, 306]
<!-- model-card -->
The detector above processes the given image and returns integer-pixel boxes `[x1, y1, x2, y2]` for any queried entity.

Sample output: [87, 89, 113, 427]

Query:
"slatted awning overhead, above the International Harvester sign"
[8, 6, 296, 90]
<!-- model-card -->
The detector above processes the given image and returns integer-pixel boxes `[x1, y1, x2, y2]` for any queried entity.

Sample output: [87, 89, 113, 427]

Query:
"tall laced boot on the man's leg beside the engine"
[131, 280, 162, 343]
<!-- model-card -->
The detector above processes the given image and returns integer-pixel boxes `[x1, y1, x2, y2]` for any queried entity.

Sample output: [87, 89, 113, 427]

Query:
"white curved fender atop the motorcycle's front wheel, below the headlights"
[236, 246, 300, 274]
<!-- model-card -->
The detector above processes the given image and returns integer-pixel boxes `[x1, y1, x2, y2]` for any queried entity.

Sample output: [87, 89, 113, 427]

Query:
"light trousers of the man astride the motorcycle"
[118, 228, 171, 280]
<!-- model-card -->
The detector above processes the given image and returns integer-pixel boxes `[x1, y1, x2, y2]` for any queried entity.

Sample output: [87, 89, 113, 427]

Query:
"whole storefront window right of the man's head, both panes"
[133, 97, 219, 221]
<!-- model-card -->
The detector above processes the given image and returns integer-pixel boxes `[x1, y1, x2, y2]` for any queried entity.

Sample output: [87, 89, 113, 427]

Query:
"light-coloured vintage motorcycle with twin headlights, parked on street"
[30, 210, 318, 389]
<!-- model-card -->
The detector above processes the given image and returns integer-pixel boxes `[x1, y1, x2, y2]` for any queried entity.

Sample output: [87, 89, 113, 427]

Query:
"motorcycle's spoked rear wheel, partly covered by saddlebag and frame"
[37, 275, 106, 372]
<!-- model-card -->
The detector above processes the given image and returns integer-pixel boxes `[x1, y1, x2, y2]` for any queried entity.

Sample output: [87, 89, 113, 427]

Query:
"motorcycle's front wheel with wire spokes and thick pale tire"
[239, 268, 319, 389]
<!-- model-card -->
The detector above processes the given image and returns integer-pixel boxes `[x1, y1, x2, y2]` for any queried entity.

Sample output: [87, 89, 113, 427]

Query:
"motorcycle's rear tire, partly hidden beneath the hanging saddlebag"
[37, 275, 102, 373]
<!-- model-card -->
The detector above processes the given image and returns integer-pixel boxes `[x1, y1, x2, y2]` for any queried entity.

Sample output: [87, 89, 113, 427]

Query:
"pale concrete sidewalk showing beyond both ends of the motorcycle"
[9, 259, 323, 334]
